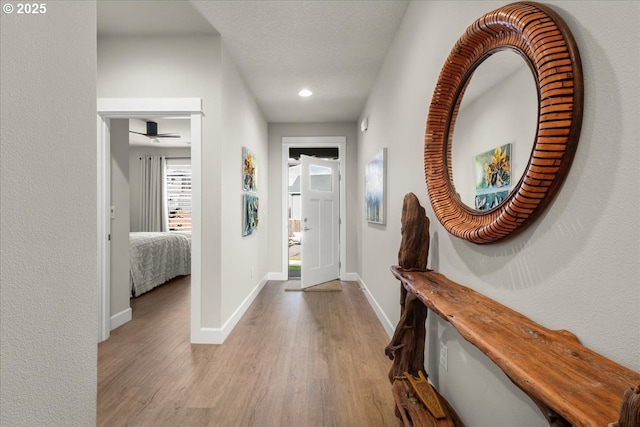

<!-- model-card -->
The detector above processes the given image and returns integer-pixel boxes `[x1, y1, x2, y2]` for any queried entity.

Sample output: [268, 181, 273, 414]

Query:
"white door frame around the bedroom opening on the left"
[97, 98, 203, 342]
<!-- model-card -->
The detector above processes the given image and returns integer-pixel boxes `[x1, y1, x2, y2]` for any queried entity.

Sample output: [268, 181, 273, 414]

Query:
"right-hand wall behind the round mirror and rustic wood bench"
[358, 1, 640, 427]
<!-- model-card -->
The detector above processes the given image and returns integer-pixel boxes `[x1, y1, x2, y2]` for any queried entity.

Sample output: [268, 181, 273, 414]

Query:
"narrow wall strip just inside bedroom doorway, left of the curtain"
[109, 119, 131, 316]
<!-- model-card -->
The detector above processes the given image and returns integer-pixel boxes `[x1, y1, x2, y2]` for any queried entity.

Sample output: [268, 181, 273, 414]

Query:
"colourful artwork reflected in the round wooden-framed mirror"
[475, 144, 511, 210]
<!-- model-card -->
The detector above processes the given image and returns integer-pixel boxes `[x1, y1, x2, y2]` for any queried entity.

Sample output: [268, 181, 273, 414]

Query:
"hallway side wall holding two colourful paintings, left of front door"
[220, 45, 270, 320]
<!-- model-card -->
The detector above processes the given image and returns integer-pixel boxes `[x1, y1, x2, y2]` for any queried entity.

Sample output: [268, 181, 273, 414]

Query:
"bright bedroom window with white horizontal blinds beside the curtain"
[165, 158, 191, 231]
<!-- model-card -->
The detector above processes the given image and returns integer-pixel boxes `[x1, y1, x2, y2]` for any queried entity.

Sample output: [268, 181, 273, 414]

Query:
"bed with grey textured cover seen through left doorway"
[129, 232, 191, 297]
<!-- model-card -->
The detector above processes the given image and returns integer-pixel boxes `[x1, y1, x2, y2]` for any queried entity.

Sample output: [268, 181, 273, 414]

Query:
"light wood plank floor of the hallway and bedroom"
[97, 277, 400, 427]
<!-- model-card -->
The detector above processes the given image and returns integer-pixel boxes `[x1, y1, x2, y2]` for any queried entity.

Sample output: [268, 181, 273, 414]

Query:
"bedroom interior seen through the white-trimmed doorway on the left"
[110, 118, 191, 329]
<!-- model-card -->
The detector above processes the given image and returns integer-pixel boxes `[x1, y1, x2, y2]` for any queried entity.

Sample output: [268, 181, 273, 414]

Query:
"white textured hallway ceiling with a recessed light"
[98, 0, 408, 123]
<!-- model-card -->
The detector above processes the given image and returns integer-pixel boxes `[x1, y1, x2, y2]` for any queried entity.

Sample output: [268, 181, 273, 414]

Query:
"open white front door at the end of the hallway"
[300, 155, 340, 288]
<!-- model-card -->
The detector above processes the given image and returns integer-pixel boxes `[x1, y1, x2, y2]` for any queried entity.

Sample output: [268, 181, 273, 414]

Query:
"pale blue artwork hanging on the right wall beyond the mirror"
[364, 148, 387, 224]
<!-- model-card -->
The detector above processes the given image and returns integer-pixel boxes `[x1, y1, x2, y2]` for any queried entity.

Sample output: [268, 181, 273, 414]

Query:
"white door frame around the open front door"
[274, 136, 347, 280]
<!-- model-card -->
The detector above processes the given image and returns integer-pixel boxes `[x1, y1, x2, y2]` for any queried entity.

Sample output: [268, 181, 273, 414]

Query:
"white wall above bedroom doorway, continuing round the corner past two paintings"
[98, 35, 268, 331]
